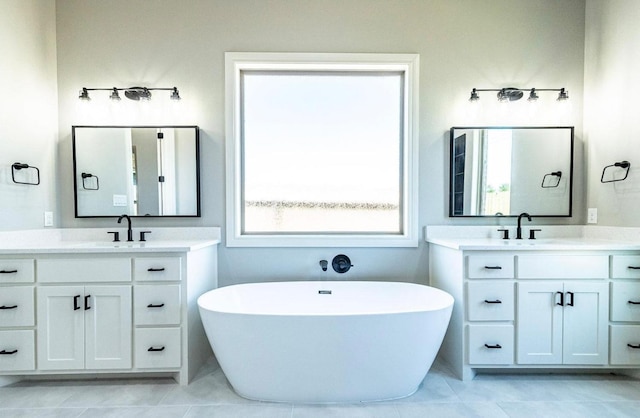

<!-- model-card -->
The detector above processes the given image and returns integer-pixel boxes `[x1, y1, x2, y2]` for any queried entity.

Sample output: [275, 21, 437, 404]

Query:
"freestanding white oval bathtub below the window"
[198, 281, 453, 403]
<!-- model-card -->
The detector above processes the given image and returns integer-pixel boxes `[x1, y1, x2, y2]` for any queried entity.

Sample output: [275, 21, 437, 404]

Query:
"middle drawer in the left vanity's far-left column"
[0, 286, 35, 327]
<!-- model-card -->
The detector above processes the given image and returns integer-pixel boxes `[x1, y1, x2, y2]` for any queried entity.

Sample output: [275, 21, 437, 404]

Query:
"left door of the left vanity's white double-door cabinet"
[37, 286, 84, 370]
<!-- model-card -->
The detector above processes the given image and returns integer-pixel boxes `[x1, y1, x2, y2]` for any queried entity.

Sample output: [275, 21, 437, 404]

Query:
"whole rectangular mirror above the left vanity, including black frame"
[72, 126, 200, 218]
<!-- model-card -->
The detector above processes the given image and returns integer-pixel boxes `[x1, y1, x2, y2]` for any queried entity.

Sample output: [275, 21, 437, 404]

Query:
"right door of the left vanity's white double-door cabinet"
[83, 286, 132, 369]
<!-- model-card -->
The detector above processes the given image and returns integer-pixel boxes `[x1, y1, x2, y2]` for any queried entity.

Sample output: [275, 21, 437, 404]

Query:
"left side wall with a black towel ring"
[0, 0, 57, 231]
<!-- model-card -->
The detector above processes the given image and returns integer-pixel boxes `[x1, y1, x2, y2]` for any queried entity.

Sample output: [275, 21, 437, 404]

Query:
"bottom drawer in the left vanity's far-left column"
[0, 330, 36, 372]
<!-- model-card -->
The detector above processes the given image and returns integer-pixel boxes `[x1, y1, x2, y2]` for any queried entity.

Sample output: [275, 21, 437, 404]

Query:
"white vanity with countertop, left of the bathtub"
[0, 228, 220, 384]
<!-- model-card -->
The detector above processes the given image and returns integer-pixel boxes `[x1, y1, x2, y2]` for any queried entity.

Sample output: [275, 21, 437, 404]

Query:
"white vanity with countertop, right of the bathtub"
[427, 227, 640, 380]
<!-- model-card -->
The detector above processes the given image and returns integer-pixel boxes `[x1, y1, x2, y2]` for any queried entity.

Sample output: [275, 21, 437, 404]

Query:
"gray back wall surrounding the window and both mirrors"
[5, 0, 585, 284]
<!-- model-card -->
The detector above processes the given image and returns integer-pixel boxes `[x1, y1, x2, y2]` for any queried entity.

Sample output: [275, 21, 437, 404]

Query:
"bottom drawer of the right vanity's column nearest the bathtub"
[467, 325, 514, 365]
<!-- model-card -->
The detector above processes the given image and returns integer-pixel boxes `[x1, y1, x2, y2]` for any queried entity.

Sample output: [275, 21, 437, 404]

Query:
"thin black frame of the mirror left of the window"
[71, 125, 202, 218]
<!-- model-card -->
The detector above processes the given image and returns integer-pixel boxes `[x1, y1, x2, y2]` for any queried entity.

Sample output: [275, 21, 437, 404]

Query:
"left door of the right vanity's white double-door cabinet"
[516, 282, 563, 364]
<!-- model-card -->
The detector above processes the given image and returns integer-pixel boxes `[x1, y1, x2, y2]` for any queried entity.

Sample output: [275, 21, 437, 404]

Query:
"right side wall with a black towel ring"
[584, 0, 640, 227]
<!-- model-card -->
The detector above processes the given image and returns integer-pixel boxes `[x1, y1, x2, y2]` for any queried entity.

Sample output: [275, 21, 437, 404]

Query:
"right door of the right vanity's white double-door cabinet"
[562, 282, 609, 364]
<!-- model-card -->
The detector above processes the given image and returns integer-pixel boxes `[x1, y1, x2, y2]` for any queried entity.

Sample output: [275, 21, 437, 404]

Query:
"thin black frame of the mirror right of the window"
[449, 126, 575, 218]
